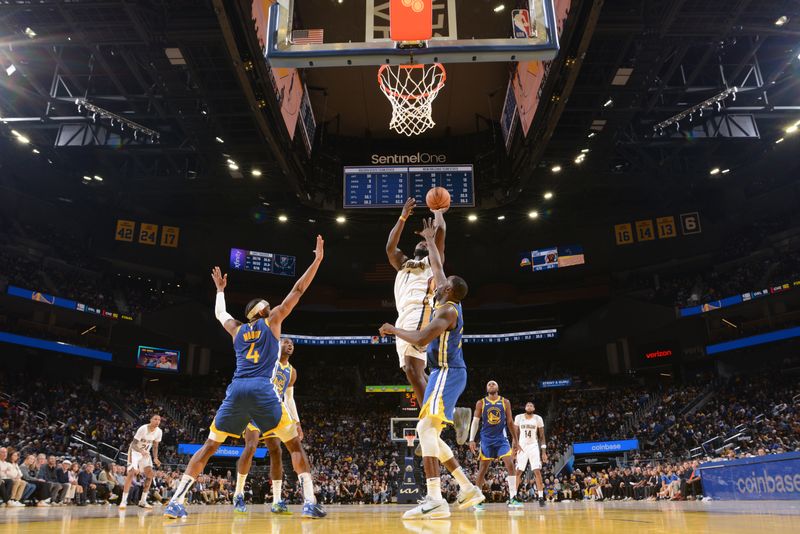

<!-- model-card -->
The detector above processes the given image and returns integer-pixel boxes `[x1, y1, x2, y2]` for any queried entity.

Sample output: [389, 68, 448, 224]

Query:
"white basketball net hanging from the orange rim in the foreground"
[378, 63, 447, 137]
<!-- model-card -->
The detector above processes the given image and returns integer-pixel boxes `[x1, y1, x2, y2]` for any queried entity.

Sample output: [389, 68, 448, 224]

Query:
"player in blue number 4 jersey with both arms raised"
[164, 236, 326, 519]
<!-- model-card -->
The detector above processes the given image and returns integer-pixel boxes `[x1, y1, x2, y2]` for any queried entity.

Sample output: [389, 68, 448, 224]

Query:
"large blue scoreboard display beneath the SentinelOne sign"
[343, 165, 475, 208]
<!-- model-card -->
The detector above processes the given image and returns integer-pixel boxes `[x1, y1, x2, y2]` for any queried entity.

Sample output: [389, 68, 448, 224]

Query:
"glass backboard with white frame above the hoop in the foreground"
[265, 0, 558, 68]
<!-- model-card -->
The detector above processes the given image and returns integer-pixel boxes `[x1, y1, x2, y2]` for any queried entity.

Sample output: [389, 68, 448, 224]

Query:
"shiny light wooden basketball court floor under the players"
[0, 501, 800, 534]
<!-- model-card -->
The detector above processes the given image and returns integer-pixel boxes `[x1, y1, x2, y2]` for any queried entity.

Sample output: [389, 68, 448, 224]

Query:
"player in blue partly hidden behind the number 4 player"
[238, 337, 303, 515]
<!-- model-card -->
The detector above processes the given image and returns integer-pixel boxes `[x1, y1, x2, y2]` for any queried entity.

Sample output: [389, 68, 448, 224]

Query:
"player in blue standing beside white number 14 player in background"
[469, 380, 522, 511]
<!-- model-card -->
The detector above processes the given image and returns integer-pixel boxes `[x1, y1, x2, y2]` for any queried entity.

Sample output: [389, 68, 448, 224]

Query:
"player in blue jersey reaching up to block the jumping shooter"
[380, 220, 485, 519]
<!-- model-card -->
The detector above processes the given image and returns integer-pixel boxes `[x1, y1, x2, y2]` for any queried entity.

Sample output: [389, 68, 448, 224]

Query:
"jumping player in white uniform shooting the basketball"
[386, 198, 471, 445]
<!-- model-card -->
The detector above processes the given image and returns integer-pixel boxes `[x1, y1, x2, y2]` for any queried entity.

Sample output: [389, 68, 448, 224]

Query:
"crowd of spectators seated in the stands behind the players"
[0, 360, 800, 507]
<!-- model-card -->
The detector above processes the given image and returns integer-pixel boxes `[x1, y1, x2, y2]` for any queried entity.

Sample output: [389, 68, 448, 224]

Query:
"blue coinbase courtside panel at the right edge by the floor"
[700, 452, 800, 501]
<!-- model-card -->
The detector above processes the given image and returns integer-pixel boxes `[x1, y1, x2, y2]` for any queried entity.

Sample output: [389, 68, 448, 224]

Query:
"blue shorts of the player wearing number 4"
[209, 377, 291, 443]
